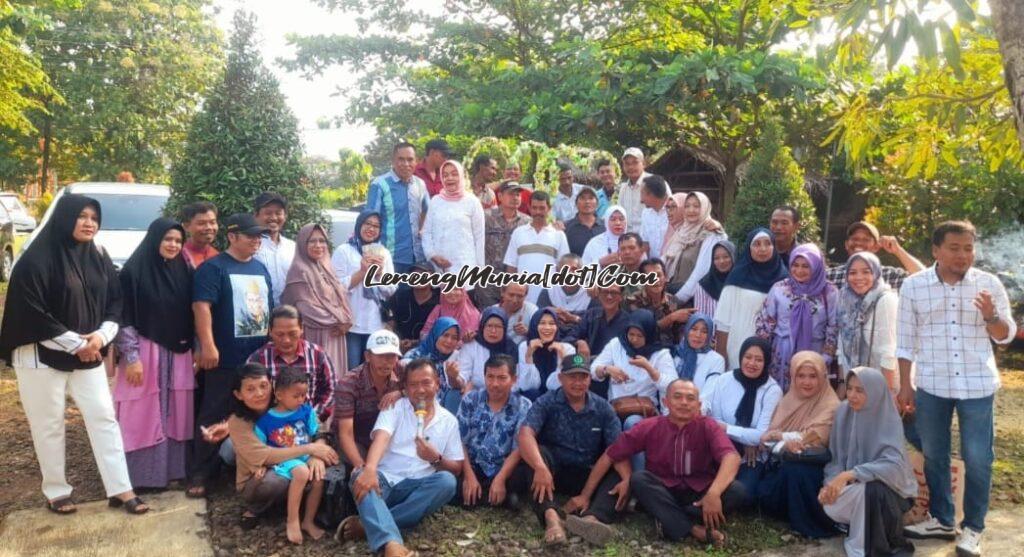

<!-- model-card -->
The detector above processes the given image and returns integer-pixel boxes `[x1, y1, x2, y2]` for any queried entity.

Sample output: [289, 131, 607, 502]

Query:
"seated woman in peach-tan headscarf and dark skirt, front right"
[757, 350, 839, 539]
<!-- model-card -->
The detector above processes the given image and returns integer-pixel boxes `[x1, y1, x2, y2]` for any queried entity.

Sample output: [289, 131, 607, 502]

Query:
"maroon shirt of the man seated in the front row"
[607, 416, 736, 494]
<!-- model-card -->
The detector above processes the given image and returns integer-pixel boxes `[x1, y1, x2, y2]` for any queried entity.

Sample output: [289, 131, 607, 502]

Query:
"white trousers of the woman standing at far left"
[14, 365, 131, 501]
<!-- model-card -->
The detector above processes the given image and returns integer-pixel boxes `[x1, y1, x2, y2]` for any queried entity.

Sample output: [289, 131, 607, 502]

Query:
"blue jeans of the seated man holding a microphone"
[349, 470, 456, 552]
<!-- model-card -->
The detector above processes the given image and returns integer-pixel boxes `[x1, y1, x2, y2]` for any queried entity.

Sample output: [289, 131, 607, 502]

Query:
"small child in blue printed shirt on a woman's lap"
[255, 370, 324, 544]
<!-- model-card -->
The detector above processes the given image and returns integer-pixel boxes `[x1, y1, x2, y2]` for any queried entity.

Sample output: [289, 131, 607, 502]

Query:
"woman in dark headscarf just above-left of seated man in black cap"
[517, 307, 575, 401]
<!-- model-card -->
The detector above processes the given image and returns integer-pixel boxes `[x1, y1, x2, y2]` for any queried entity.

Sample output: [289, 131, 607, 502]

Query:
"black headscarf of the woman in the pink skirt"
[120, 217, 194, 353]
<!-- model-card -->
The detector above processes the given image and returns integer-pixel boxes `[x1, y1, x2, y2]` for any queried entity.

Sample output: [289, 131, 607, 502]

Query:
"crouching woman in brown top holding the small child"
[227, 363, 338, 534]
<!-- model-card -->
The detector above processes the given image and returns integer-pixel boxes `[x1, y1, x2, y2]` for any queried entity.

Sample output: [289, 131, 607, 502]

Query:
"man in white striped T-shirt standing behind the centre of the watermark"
[505, 191, 569, 303]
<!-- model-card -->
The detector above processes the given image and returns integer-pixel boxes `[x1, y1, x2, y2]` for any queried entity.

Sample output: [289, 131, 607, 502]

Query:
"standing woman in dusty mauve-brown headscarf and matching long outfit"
[281, 224, 352, 378]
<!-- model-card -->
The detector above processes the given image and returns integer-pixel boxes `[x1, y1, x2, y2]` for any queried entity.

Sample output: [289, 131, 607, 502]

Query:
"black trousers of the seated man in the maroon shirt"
[630, 470, 744, 542]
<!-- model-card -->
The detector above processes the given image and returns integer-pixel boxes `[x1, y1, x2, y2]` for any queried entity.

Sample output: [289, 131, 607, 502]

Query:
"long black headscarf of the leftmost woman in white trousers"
[0, 195, 121, 372]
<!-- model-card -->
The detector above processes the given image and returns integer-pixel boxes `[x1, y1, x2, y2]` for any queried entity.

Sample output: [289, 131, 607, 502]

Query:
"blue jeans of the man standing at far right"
[914, 389, 995, 531]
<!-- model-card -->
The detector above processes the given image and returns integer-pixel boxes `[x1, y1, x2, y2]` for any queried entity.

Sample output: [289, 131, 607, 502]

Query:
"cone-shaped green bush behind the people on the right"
[726, 123, 821, 243]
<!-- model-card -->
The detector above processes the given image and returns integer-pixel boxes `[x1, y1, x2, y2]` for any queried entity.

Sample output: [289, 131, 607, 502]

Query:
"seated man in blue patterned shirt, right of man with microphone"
[457, 354, 530, 507]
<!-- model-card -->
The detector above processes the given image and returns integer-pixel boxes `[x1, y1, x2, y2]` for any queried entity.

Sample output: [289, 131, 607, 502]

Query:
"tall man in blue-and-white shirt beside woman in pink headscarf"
[364, 142, 430, 272]
